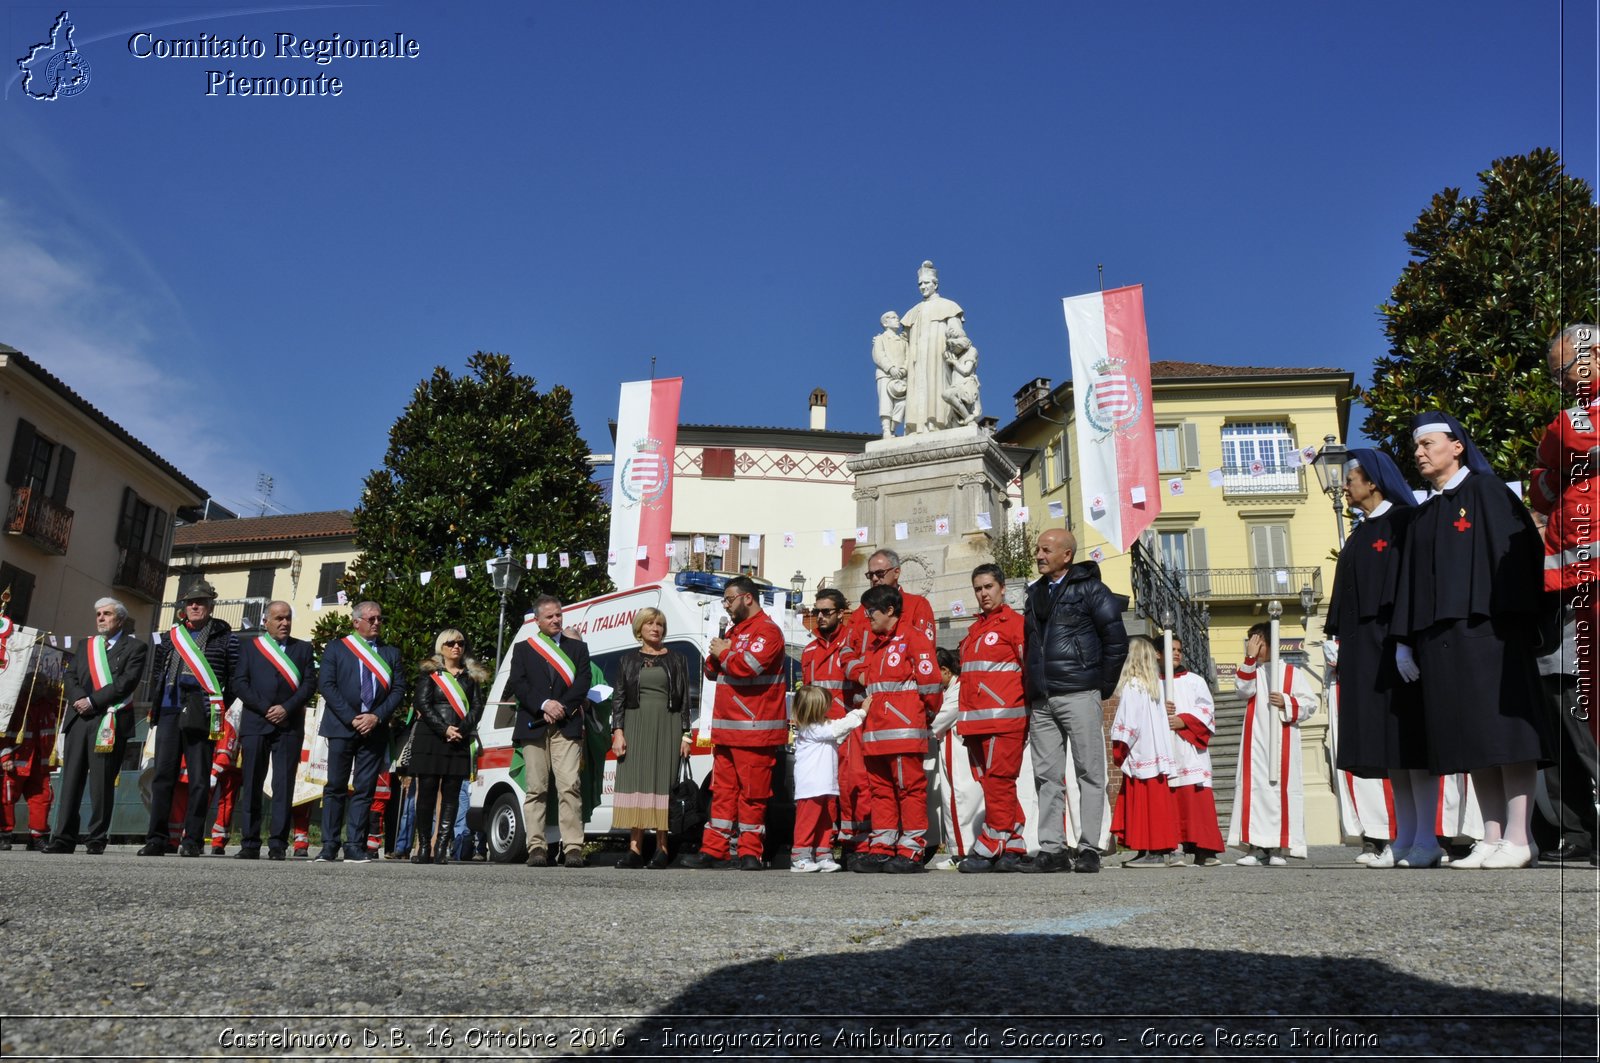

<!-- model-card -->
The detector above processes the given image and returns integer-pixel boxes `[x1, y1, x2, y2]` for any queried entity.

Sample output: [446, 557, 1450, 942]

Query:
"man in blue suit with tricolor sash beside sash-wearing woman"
[317, 602, 406, 863]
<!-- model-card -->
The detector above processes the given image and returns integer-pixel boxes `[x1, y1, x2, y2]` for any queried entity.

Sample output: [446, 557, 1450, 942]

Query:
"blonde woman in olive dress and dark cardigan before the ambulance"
[611, 607, 693, 869]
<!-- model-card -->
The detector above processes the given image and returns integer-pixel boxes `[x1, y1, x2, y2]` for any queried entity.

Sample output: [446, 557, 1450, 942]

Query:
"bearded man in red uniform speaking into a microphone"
[678, 576, 789, 871]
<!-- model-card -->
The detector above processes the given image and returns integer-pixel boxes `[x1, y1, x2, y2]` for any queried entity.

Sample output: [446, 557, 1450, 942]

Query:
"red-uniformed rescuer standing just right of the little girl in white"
[845, 586, 944, 874]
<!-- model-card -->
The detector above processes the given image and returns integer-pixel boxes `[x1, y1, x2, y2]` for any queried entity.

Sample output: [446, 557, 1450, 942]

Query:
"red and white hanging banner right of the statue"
[1061, 285, 1162, 551]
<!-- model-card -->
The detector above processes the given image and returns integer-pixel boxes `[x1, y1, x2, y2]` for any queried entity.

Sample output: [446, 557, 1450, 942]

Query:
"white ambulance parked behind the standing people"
[467, 572, 811, 863]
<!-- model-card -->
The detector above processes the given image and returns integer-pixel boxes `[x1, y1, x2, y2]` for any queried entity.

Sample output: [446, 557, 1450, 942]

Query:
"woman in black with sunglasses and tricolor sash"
[411, 628, 490, 863]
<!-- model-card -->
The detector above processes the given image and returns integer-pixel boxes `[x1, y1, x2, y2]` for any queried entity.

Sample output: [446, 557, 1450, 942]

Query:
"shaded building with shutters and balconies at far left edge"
[0, 344, 206, 636]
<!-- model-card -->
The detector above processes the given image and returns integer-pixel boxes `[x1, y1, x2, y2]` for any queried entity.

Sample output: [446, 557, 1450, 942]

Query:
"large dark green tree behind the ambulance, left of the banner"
[346, 351, 611, 669]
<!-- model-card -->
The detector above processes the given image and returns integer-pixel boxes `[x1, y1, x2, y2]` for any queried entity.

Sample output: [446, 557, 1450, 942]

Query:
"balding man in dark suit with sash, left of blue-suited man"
[232, 602, 317, 860]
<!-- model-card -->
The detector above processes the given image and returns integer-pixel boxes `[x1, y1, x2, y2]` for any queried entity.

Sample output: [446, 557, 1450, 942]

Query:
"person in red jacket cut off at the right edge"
[1528, 325, 1600, 863]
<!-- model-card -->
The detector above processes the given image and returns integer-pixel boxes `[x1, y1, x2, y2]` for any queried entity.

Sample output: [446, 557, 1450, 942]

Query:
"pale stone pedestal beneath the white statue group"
[834, 424, 1018, 645]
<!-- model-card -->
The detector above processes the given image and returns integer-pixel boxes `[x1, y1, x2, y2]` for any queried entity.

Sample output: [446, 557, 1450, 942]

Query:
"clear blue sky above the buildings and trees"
[0, 0, 1597, 512]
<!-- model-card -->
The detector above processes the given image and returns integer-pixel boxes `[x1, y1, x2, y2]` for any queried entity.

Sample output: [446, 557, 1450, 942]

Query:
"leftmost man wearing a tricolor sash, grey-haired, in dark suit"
[46, 599, 149, 855]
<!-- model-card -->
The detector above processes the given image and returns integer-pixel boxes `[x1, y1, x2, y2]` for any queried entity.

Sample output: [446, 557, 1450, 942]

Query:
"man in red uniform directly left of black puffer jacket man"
[955, 565, 1027, 874]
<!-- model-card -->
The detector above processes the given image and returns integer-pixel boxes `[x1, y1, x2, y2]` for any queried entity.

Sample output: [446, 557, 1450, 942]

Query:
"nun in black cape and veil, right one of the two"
[1394, 411, 1549, 869]
